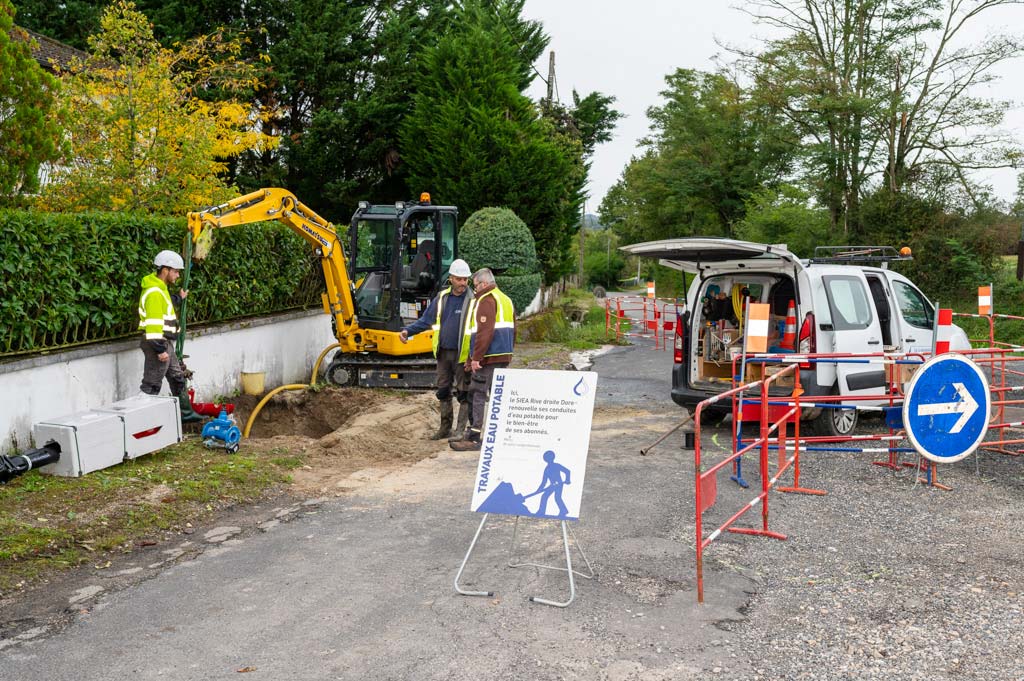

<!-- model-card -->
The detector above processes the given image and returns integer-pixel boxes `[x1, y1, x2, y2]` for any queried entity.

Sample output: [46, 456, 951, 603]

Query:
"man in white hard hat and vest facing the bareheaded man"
[398, 259, 473, 440]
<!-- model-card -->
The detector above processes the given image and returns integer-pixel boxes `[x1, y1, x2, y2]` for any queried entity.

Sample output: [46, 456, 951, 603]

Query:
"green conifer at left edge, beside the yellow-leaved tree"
[0, 0, 61, 197]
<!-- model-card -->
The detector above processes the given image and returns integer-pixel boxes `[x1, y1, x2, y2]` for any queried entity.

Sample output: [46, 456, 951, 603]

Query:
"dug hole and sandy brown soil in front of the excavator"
[234, 388, 447, 496]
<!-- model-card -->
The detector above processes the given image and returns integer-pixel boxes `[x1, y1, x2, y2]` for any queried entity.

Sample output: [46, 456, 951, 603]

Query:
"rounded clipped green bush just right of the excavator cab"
[459, 208, 541, 314]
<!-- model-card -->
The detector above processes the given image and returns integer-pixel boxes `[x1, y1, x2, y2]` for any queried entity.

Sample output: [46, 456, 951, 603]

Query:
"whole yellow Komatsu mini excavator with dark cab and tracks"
[188, 188, 459, 388]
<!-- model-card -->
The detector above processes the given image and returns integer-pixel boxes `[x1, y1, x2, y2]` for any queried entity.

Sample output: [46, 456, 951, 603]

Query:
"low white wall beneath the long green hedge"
[0, 310, 334, 453]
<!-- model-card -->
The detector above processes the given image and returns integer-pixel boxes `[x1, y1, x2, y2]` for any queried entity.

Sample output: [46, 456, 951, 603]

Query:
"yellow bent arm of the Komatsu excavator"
[188, 187, 367, 352]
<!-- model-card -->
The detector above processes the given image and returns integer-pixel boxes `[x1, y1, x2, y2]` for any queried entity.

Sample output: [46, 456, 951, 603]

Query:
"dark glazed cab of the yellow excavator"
[348, 195, 459, 332]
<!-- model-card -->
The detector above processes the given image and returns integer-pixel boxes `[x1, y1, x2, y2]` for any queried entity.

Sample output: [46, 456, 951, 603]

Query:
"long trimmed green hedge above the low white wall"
[0, 210, 324, 356]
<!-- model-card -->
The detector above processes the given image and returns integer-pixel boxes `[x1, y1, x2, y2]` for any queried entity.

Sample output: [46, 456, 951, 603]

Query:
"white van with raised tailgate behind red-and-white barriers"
[623, 238, 971, 435]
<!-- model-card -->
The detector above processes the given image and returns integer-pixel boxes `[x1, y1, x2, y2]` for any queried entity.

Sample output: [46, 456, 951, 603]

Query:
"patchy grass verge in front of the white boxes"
[0, 439, 303, 592]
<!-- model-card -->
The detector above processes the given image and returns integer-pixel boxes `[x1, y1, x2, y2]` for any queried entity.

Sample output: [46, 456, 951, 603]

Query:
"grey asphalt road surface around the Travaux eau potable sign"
[0, 327, 754, 681]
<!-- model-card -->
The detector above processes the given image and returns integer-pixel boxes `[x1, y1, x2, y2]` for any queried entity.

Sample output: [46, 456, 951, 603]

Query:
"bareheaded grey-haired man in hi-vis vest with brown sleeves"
[449, 268, 515, 452]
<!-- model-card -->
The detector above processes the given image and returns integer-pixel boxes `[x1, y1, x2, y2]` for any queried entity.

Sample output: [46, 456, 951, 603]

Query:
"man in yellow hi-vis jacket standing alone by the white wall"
[138, 246, 202, 423]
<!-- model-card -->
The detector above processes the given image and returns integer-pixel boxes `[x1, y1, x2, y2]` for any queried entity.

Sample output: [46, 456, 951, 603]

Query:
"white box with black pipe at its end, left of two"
[32, 411, 125, 477]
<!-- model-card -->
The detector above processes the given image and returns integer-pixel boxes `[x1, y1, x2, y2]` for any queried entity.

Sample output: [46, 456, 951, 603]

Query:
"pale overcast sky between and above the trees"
[523, 0, 1024, 212]
